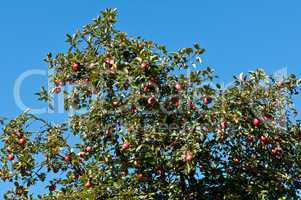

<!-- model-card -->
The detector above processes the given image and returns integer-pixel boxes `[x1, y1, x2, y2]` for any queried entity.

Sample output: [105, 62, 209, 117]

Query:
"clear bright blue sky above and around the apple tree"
[0, 0, 301, 196]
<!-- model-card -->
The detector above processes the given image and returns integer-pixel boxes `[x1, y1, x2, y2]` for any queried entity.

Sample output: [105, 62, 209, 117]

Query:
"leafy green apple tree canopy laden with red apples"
[0, 9, 301, 200]
